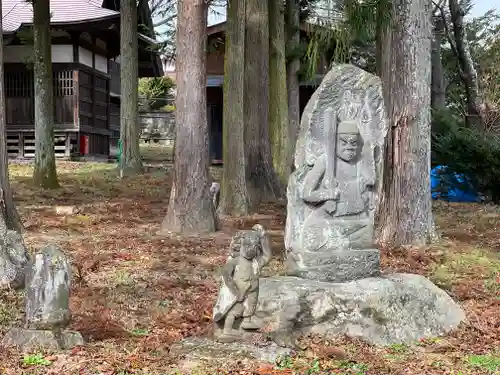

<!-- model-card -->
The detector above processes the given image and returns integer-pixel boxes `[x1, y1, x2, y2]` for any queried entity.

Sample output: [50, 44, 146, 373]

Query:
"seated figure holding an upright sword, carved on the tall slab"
[301, 111, 375, 251]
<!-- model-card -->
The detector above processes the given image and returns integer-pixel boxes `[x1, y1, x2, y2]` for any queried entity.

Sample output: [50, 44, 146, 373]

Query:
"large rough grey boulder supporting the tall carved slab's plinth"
[254, 274, 465, 345]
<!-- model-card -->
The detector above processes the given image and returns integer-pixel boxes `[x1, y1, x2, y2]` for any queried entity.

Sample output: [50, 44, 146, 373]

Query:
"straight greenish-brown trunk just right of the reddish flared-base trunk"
[219, 0, 250, 216]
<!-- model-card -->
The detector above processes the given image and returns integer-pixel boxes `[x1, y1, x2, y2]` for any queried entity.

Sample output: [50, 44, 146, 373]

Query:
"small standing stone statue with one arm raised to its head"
[213, 224, 271, 343]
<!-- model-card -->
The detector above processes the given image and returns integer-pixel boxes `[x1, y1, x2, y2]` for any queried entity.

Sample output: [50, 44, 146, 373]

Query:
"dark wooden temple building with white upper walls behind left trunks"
[2, 0, 163, 158]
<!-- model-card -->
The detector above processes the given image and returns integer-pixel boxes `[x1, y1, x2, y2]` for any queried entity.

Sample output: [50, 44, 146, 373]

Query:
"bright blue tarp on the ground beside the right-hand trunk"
[431, 165, 481, 202]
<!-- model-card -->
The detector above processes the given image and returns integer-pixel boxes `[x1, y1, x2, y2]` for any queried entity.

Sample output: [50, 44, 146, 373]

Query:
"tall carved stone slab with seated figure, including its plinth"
[285, 66, 387, 282]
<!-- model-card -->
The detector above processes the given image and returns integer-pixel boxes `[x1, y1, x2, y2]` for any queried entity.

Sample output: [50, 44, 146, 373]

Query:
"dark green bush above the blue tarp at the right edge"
[432, 112, 500, 203]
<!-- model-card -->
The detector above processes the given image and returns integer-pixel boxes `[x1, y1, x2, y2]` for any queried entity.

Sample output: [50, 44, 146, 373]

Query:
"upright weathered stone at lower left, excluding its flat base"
[26, 245, 71, 330]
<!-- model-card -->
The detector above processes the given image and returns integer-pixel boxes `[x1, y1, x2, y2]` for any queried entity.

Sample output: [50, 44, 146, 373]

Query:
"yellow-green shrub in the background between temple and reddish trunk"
[138, 76, 175, 110]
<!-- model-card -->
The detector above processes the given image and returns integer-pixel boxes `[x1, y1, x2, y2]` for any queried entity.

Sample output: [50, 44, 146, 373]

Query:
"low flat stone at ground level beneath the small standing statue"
[170, 337, 292, 363]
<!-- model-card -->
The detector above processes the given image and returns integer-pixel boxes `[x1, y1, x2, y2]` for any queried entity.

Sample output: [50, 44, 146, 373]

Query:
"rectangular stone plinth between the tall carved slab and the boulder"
[286, 249, 380, 283]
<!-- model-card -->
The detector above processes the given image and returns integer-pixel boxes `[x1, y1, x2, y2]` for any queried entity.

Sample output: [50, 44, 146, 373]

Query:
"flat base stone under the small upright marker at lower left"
[2, 328, 84, 352]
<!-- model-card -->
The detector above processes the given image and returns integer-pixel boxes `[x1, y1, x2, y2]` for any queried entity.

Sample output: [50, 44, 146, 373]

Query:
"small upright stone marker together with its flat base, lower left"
[2, 245, 83, 351]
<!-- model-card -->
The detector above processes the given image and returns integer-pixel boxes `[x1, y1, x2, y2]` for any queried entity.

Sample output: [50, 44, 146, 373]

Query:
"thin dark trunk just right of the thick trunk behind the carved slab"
[431, 17, 446, 111]
